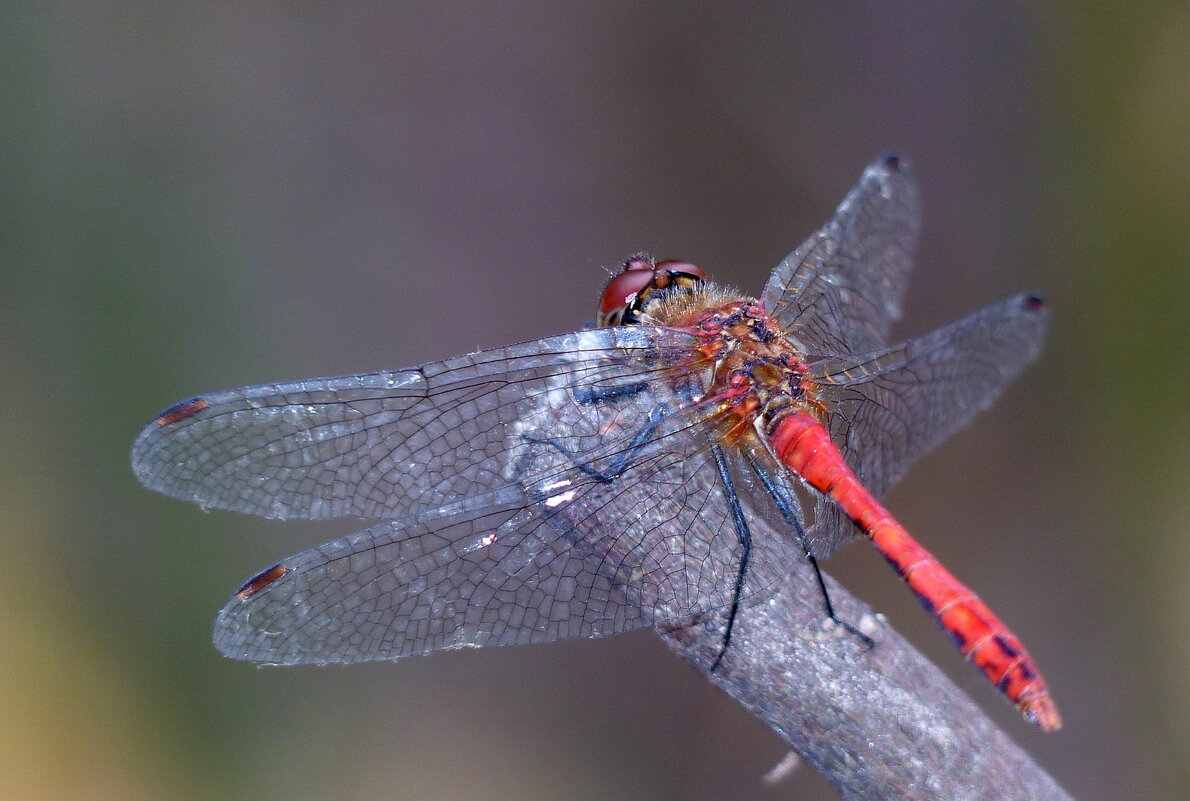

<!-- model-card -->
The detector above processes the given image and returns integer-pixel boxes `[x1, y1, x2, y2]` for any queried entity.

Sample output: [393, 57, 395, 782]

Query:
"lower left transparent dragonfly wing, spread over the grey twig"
[214, 378, 800, 664]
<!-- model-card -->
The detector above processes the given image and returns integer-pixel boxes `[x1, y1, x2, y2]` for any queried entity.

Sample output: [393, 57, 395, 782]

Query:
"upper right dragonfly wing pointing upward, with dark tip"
[762, 156, 921, 356]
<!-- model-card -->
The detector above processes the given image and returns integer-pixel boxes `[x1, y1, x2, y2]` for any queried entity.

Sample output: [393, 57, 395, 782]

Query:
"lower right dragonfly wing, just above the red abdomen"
[810, 294, 1047, 556]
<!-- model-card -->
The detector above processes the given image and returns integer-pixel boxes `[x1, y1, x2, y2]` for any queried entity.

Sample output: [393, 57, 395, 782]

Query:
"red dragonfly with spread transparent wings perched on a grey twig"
[132, 156, 1061, 731]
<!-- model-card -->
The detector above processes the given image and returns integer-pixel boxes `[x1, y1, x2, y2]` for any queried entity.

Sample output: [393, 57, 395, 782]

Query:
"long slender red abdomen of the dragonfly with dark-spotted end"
[770, 412, 1061, 732]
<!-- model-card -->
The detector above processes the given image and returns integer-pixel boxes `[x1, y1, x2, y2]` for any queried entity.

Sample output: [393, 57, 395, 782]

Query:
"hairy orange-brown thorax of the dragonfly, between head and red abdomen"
[640, 284, 822, 444]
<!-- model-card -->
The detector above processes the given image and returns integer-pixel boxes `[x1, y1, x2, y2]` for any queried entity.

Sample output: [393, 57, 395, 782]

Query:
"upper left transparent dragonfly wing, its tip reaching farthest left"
[132, 327, 694, 519]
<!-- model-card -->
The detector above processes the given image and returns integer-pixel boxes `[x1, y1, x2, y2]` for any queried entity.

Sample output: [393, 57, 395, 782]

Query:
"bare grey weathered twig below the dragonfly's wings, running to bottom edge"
[658, 532, 1070, 801]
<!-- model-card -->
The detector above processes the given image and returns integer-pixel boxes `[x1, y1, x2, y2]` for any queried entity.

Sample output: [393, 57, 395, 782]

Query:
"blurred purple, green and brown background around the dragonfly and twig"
[0, 0, 1190, 800]
